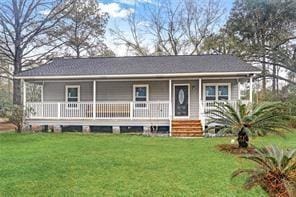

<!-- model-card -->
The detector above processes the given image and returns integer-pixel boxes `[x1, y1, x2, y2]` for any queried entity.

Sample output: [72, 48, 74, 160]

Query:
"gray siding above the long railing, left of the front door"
[43, 81, 169, 102]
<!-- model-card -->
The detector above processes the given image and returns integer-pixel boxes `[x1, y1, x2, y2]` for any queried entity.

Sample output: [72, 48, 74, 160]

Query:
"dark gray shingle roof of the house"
[18, 55, 260, 77]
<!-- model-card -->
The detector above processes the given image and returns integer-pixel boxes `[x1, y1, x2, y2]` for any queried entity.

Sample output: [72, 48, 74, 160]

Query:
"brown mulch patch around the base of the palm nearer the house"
[216, 144, 255, 155]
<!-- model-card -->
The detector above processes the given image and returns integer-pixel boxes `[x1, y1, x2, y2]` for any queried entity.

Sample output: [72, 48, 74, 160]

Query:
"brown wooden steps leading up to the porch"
[172, 120, 203, 137]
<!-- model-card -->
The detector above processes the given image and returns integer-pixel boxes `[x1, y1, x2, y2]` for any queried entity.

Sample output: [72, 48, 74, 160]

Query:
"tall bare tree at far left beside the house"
[0, 0, 71, 104]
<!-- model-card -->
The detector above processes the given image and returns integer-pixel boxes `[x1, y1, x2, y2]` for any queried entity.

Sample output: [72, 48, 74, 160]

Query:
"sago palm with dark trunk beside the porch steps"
[207, 102, 289, 147]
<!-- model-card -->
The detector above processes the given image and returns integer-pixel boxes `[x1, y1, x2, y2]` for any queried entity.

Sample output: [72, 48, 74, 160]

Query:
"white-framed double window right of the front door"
[204, 83, 230, 101]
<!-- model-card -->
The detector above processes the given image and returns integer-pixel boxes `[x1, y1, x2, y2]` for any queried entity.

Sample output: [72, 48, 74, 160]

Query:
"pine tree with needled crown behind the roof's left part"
[48, 0, 110, 58]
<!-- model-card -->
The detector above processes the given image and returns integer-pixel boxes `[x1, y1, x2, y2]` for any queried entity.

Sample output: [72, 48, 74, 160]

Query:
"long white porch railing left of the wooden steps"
[26, 101, 169, 120]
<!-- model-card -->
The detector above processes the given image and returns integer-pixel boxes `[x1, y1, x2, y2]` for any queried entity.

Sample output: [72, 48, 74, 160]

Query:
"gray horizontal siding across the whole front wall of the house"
[43, 79, 238, 119]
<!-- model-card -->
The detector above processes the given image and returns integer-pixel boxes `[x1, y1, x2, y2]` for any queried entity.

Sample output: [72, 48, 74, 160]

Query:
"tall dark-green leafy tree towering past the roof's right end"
[205, 0, 296, 93]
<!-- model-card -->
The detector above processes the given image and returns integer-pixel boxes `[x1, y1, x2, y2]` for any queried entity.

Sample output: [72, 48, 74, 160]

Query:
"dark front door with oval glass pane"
[175, 85, 189, 117]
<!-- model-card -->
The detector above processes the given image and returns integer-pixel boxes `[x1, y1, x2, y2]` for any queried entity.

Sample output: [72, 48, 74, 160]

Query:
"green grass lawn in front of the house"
[0, 133, 296, 196]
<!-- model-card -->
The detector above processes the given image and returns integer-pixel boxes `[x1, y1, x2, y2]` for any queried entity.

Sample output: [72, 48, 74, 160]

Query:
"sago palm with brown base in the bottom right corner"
[232, 145, 296, 197]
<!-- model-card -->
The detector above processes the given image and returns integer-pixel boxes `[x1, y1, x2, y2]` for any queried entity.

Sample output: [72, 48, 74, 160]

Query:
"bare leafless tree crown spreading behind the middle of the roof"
[111, 0, 224, 55]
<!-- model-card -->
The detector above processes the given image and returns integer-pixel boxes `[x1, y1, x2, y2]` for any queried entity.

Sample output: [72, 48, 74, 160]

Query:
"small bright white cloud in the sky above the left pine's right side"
[99, 3, 135, 18]
